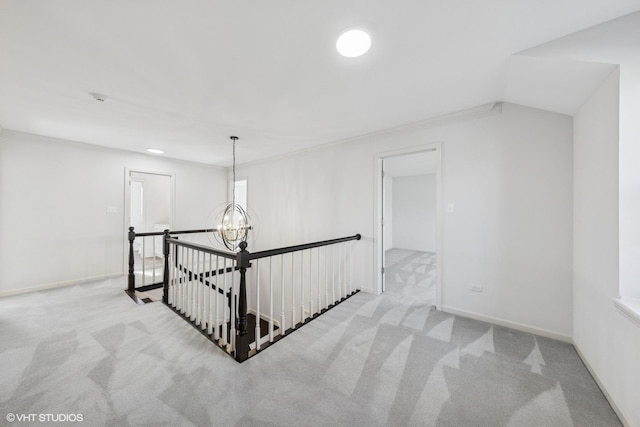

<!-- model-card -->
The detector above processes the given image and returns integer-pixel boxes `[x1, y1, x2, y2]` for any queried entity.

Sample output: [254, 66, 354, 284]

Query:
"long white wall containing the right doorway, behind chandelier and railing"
[238, 104, 573, 337]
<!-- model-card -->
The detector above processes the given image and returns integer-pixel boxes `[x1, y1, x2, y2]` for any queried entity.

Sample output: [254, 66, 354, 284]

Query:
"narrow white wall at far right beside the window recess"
[573, 71, 640, 425]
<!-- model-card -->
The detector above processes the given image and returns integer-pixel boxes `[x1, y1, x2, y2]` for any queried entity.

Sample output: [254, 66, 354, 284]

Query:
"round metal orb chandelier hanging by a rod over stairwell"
[215, 136, 251, 252]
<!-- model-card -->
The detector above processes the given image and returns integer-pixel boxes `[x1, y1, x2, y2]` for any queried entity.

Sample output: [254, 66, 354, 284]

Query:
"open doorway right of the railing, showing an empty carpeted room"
[378, 146, 441, 308]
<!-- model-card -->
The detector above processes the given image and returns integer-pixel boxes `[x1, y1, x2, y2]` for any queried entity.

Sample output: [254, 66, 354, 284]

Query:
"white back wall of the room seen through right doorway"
[393, 174, 436, 252]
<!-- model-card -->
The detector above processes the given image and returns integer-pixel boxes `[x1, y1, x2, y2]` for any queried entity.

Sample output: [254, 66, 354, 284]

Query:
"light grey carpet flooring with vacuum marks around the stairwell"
[0, 249, 621, 427]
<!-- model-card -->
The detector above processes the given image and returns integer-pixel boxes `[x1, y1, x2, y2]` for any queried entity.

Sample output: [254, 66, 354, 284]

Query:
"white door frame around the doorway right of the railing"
[373, 142, 443, 310]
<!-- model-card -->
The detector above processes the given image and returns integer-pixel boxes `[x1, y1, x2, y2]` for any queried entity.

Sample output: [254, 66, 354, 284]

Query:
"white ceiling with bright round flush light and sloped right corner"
[0, 0, 640, 165]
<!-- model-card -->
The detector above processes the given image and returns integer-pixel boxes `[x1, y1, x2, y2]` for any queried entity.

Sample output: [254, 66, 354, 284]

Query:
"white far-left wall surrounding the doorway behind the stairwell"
[0, 130, 226, 294]
